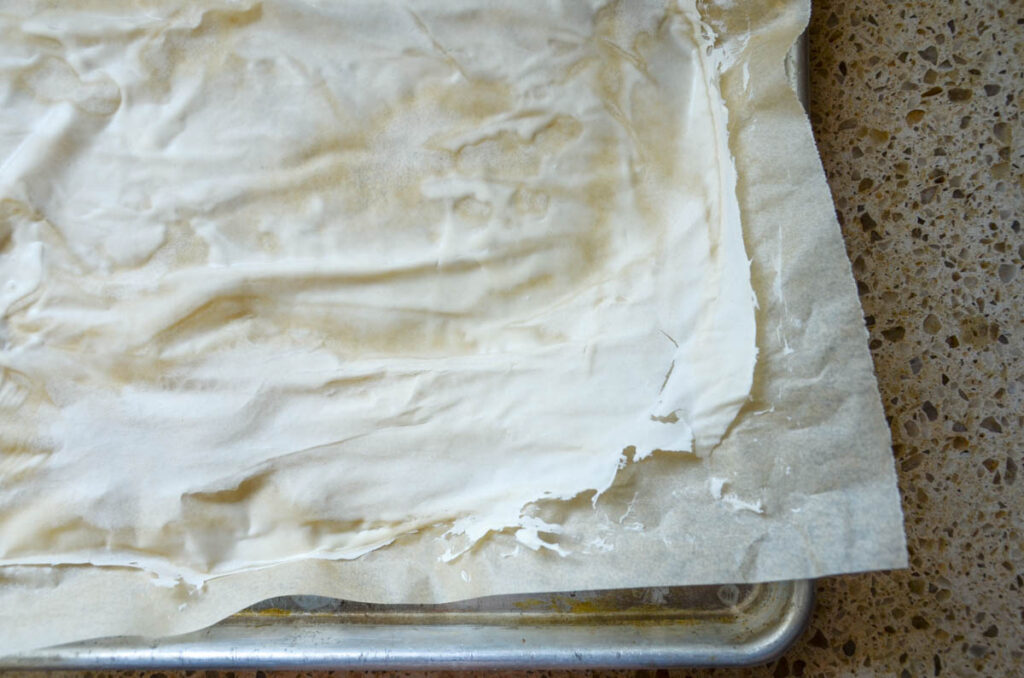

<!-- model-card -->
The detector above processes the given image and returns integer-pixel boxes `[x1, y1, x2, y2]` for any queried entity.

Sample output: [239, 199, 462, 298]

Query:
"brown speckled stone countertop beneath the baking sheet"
[5, 0, 1024, 678]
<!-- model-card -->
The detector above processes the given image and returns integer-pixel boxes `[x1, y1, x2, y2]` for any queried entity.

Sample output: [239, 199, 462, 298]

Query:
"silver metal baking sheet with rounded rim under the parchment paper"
[0, 34, 814, 670]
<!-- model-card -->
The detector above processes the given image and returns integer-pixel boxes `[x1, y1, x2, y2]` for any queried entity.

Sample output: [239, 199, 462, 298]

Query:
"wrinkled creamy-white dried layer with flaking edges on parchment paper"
[0, 0, 756, 584]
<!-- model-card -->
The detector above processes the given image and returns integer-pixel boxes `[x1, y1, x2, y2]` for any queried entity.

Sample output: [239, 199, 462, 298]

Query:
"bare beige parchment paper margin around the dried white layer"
[0, 0, 906, 653]
